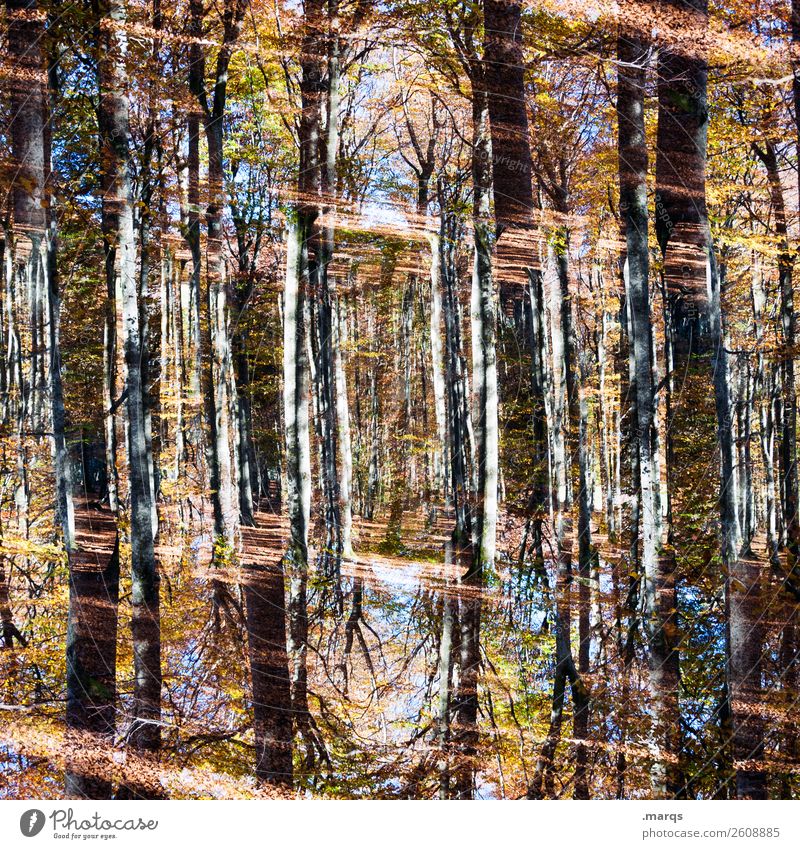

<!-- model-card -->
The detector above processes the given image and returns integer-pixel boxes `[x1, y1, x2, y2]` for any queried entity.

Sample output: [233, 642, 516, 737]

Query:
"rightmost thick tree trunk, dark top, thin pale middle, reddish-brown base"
[656, 0, 766, 798]
